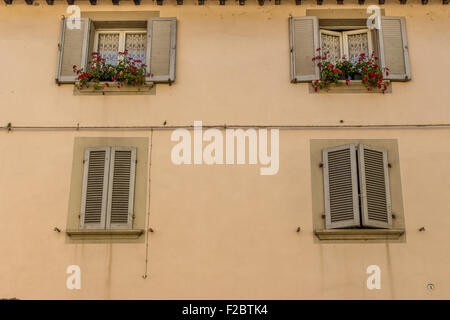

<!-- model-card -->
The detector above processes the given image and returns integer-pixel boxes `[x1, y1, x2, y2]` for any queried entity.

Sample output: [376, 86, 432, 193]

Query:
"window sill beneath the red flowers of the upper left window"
[74, 82, 155, 95]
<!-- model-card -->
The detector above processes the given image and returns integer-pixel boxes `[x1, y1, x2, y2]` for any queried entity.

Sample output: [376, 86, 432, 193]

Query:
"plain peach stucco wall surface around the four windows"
[0, 1, 450, 299]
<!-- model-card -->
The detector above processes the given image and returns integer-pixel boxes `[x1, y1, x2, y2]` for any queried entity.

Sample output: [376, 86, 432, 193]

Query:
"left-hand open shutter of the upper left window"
[56, 18, 90, 83]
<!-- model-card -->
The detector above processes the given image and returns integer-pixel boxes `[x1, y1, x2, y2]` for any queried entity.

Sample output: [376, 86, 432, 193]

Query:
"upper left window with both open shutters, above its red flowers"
[56, 18, 177, 84]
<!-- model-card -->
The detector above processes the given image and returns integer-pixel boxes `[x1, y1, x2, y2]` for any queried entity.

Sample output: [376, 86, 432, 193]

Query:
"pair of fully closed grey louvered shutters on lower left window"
[80, 147, 136, 229]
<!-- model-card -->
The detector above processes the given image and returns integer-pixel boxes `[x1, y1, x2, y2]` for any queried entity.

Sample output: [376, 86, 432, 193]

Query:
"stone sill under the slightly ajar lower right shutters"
[314, 229, 405, 240]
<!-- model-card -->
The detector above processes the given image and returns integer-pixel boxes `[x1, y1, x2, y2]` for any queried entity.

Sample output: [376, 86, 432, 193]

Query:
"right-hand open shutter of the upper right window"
[378, 16, 411, 81]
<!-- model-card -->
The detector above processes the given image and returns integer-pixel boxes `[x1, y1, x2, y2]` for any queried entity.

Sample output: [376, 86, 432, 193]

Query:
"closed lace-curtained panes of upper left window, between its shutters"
[94, 30, 147, 65]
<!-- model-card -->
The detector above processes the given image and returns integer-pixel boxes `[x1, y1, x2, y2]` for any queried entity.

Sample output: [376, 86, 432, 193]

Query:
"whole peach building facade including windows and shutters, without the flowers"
[0, 0, 450, 299]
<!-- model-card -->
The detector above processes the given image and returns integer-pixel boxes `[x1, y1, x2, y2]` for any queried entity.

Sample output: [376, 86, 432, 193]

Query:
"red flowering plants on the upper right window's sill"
[312, 48, 389, 93]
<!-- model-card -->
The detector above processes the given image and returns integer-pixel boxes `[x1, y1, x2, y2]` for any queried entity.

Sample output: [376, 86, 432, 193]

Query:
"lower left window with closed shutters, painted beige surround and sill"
[66, 137, 149, 243]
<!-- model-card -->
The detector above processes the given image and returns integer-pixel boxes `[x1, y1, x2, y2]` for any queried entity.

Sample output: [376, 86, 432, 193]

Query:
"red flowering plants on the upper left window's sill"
[73, 50, 149, 91]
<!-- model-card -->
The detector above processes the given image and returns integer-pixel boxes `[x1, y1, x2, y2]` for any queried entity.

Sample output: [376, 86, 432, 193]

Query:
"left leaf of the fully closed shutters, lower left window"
[80, 147, 110, 229]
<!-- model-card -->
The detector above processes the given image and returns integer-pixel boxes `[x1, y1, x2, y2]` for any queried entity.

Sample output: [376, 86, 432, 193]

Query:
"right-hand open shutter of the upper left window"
[146, 18, 177, 83]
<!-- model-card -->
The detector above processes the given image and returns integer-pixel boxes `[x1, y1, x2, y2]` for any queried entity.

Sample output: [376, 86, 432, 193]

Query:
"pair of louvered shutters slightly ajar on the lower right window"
[322, 144, 392, 229]
